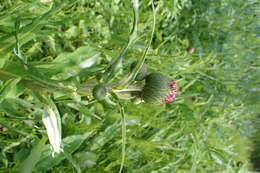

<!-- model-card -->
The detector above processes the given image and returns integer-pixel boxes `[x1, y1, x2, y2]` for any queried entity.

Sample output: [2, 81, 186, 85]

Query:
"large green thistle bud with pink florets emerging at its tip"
[141, 73, 177, 104]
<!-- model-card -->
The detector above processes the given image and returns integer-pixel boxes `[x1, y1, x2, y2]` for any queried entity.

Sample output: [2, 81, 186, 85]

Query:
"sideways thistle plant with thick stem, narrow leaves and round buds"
[0, 0, 175, 172]
